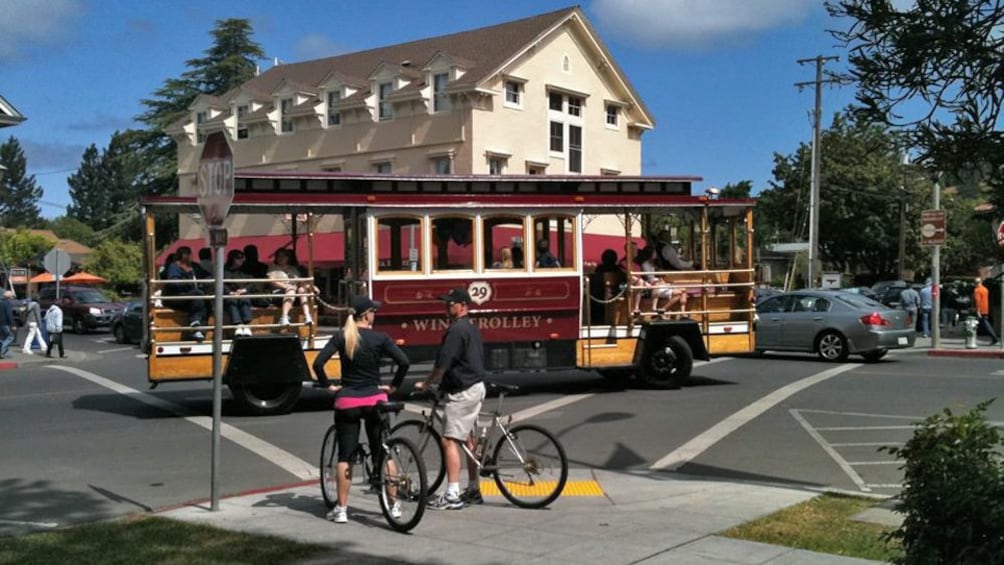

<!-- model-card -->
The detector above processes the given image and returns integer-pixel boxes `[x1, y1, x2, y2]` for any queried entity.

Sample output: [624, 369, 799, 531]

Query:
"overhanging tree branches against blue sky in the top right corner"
[826, 0, 1004, 209]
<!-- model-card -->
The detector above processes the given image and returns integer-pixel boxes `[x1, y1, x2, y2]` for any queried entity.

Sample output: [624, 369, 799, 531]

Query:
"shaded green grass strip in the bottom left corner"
[0, 517, 330, 565]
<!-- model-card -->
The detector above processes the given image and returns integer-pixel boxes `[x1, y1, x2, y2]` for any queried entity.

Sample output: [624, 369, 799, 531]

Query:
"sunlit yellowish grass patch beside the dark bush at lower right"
[722, 494, 903, 561]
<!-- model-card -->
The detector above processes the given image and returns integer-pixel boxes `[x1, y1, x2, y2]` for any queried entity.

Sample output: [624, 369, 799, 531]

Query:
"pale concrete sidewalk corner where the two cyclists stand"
[159, 470, 877, 565]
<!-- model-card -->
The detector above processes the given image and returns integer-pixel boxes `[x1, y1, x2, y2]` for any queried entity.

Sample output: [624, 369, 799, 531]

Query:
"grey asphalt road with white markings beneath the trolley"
[0, 333, 1004, 535]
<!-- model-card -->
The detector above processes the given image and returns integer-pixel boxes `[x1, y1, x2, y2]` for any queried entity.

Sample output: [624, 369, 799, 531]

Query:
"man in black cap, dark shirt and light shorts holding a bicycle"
[415, 288, 485, 510]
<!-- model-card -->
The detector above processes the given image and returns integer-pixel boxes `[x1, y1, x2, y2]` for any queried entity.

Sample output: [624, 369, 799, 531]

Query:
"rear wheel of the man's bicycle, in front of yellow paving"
[489, 423, 568, 508]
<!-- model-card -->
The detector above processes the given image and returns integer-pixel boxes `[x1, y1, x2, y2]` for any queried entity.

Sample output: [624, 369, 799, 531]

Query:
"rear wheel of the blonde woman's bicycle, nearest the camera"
[380, 438, 429, 532]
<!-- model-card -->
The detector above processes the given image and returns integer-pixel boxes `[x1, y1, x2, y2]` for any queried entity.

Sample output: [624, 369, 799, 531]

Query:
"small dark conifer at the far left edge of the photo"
[0, 135, 42, 228]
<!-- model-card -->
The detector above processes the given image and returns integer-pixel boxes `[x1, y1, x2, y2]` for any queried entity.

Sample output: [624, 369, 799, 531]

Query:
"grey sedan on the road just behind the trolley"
[756, 290, 917, 361]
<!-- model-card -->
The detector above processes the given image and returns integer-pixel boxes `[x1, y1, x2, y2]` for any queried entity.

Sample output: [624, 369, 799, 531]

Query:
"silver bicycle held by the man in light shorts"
[391, 382, 568, 508]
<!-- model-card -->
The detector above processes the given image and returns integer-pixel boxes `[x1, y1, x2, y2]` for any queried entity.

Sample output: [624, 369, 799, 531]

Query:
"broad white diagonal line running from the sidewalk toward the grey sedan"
[649, 363, 861, 471]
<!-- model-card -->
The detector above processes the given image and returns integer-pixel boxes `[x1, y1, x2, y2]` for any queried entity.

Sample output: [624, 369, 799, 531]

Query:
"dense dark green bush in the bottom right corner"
[883, 399, 1004, 565]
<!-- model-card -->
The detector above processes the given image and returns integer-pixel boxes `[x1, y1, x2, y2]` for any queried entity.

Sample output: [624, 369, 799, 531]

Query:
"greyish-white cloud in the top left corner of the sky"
[0, 0, 82, 62]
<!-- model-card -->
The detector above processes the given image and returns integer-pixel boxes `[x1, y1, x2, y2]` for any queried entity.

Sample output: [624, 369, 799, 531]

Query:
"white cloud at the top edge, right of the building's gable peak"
[592, 0, 821, 47]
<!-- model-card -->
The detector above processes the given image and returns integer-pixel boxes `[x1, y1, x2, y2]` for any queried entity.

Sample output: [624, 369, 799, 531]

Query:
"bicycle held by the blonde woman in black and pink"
[320, 402, 429, 532]
